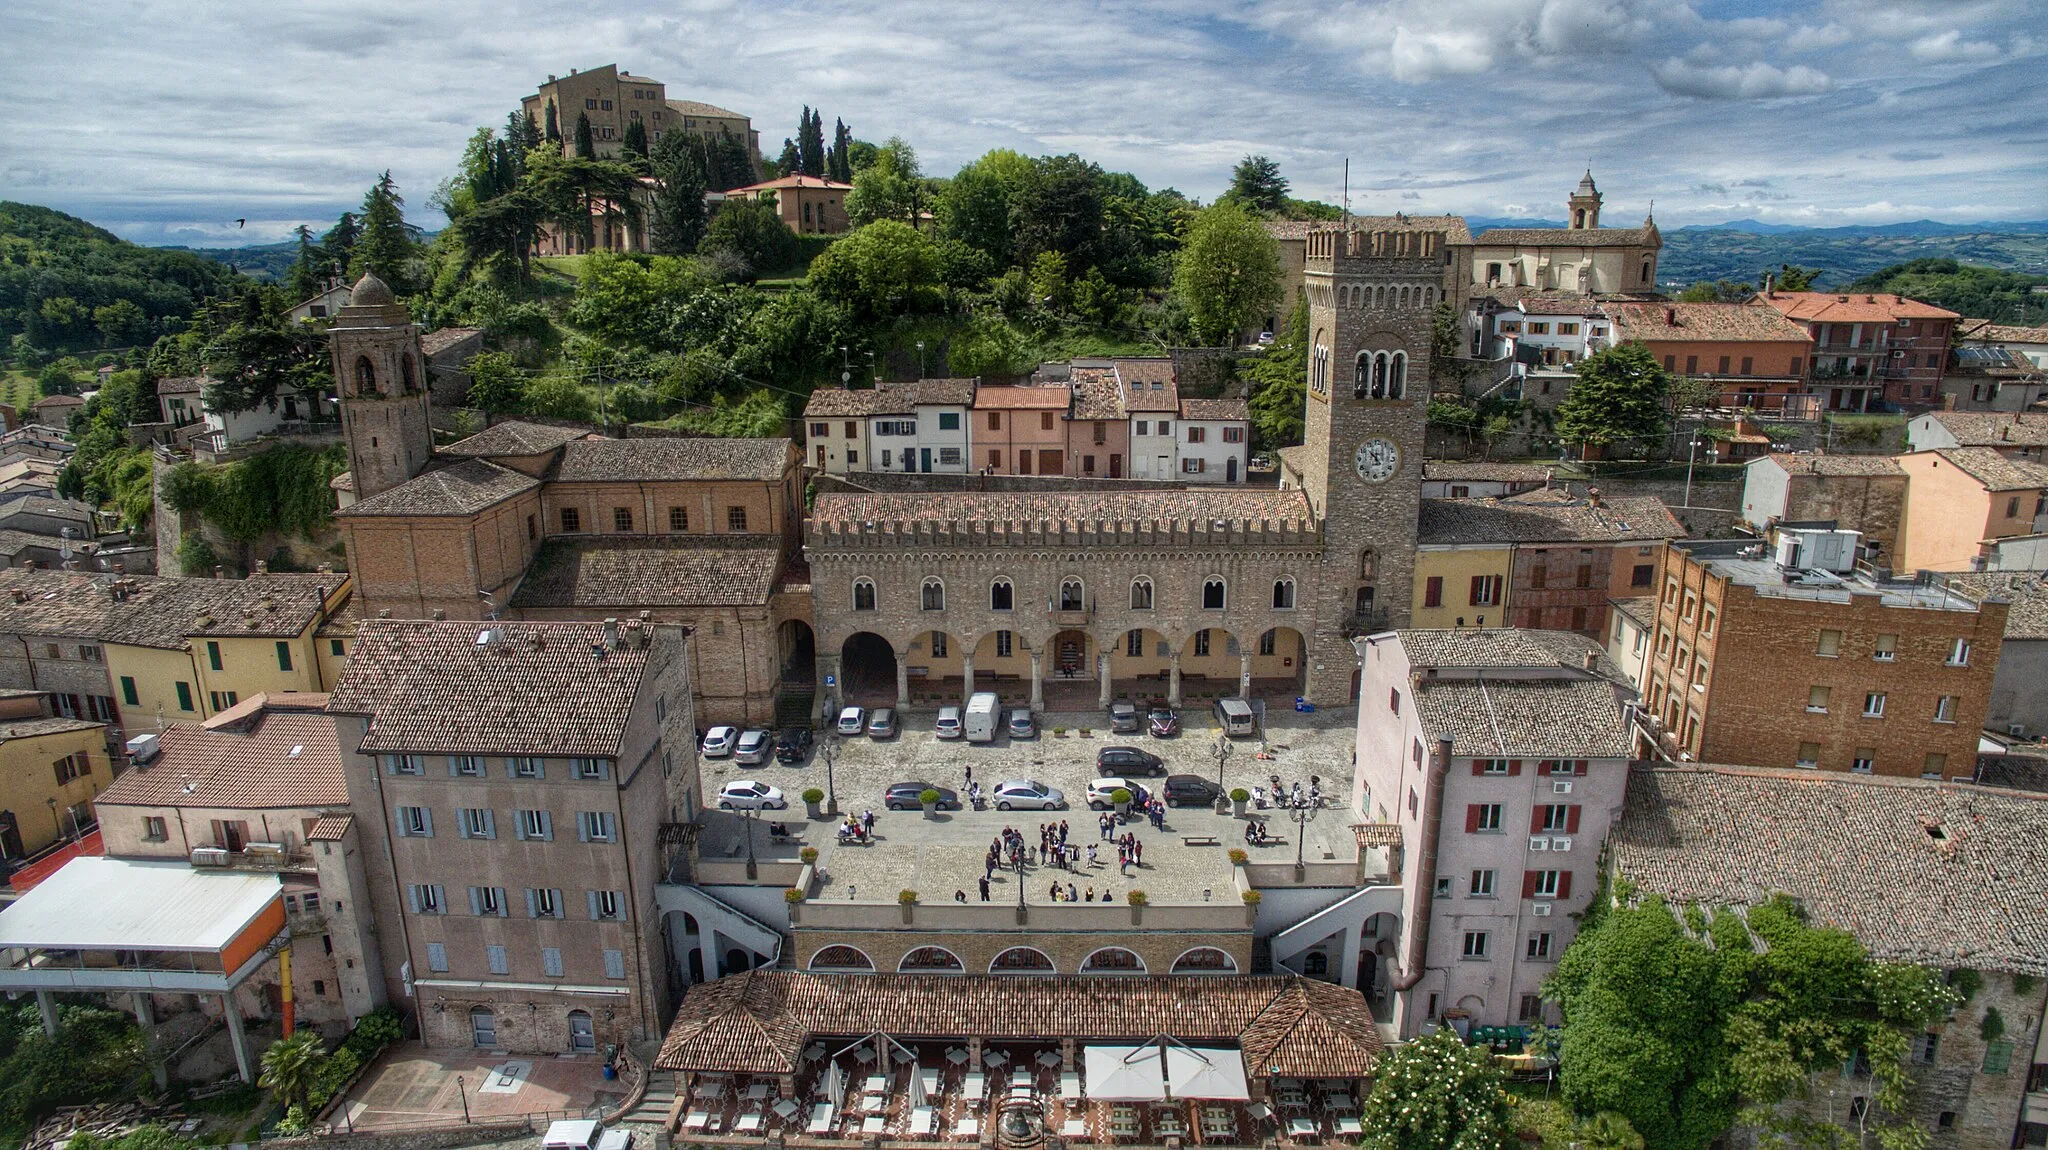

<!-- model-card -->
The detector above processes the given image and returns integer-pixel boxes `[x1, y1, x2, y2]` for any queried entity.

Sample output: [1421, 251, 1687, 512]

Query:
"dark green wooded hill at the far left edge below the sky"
[0, 201, 238, 352]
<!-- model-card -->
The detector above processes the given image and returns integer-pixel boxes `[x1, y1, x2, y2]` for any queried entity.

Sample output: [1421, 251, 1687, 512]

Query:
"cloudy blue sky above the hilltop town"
[0, 0, 2048, 244]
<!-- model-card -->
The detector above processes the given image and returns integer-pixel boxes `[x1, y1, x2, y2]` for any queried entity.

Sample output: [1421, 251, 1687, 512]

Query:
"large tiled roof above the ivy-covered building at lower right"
[1612, 765, 2048, 976]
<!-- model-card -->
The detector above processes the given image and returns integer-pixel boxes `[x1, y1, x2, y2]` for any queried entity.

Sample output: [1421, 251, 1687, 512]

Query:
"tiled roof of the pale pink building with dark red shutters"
[1415, 677, 1628, 759]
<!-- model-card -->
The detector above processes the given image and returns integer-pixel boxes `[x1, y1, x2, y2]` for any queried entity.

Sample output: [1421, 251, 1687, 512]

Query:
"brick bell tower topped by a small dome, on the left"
[328, 274, 434, 499]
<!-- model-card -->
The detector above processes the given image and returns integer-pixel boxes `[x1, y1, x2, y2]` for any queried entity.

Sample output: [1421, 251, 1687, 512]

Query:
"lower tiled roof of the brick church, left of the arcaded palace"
[512, 534, 782, 614]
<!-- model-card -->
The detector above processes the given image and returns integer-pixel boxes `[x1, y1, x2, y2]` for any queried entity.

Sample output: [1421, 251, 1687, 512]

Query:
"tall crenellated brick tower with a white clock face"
[1303, 215, 1452, 706]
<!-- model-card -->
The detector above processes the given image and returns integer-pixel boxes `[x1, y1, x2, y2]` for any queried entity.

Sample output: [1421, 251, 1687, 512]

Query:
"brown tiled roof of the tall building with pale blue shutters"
[328, 618, 647, 757]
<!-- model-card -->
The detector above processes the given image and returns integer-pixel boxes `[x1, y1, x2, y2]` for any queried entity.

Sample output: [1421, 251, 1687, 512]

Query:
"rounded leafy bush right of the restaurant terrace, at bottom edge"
[1358, 1027, 1516, 1150]
